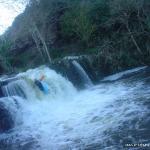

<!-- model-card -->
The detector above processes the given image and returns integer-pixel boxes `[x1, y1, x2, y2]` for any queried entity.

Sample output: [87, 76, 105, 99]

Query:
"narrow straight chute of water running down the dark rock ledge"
[72, 60, 93, 87]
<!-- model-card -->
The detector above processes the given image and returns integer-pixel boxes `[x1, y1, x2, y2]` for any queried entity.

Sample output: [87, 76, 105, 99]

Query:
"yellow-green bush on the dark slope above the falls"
[61, 1, 96, 47]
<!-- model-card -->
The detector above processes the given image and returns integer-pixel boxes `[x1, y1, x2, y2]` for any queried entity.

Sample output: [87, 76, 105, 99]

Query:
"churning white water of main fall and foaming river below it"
[0, 67, 150, 150]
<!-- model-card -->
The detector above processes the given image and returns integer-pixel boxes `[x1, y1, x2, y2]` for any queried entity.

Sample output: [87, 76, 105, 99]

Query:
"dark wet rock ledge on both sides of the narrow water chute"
[50, 55, 104, 88]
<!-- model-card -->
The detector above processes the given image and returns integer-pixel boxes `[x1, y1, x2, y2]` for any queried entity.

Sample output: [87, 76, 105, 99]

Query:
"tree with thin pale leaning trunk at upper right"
[110, 0, 144, 54]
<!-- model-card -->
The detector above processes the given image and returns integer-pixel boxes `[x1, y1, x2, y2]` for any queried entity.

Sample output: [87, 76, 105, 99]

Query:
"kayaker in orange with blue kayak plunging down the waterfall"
[34, 75, 49, 94]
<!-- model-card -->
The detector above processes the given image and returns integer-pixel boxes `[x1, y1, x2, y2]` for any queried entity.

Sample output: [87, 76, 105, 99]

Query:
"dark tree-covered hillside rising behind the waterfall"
[2, 0, 150, 72]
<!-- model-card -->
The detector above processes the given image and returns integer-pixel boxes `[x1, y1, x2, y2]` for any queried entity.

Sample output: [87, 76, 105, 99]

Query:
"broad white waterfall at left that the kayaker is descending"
[2, 67, 76, 100]
